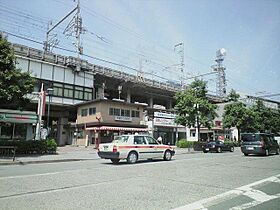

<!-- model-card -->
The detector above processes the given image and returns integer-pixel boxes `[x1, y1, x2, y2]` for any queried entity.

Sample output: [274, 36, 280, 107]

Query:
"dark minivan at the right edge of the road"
[241, 133, 279, 156]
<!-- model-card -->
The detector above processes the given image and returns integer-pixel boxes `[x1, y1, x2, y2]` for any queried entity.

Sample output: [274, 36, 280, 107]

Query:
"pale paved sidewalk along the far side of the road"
[0, 145, 197, 165]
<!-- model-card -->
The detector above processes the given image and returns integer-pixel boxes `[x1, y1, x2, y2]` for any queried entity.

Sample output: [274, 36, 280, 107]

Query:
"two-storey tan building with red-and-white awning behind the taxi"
[75, 99, 148, 145]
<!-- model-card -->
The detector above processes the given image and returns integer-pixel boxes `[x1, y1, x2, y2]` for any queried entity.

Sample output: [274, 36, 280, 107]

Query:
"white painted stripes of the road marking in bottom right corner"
[173, 174, 280, 210]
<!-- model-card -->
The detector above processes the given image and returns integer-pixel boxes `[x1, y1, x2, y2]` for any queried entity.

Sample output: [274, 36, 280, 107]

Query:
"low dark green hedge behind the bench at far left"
[0, 139, 57, 154]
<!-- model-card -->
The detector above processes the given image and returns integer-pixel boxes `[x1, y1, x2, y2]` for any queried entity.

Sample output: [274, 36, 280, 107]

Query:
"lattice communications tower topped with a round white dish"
[212, 48, 226, 98]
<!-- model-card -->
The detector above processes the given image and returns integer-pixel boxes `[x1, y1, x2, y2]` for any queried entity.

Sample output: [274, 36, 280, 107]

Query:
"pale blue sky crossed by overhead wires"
[0, 0, 280, 101]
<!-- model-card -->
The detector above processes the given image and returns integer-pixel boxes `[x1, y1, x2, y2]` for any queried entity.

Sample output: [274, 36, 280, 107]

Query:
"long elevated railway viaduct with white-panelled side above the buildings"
[8, 43, 221, 145]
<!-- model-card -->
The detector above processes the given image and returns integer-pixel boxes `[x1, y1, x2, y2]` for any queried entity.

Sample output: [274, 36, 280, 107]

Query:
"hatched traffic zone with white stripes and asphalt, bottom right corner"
[174, 174, 280, 210]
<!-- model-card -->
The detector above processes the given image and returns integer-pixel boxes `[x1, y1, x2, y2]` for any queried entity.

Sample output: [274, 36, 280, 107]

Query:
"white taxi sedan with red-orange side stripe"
[98, 134, 175, 164]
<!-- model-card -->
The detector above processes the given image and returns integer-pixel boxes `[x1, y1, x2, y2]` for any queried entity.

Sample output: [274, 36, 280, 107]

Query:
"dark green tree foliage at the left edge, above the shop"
[0, 33, 35, 108]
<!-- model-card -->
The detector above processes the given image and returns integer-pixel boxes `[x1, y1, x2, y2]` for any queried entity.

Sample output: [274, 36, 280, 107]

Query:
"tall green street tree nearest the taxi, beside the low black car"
[175, 80, 217, 139]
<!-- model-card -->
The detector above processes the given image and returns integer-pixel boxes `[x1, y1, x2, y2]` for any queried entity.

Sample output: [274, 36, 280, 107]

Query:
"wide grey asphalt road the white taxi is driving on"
[0, 149, 280, 210]
